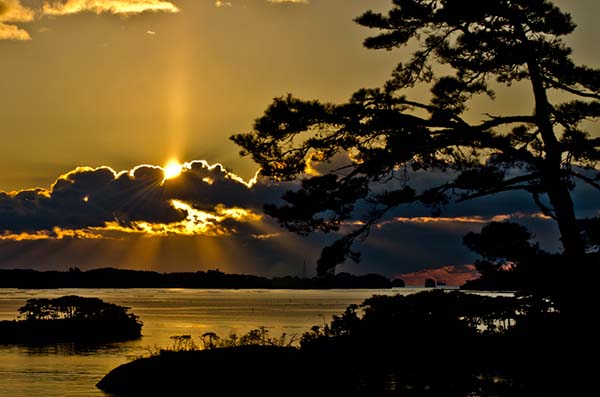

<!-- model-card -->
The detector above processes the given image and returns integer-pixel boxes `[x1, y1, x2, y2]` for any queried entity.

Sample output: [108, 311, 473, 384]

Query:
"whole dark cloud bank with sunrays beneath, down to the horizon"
[0, 161, 597, 276]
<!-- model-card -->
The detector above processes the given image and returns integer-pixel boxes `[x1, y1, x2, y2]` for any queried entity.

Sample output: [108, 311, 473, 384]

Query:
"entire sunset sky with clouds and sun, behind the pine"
[0, 0, 600, 276]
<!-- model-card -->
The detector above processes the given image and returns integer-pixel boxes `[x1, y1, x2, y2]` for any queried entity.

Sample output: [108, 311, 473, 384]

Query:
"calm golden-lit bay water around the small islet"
[0, 288, 418, 397]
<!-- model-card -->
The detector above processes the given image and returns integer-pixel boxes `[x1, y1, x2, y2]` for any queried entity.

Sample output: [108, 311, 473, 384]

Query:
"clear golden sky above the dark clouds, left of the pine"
[0, 0, 404, 190]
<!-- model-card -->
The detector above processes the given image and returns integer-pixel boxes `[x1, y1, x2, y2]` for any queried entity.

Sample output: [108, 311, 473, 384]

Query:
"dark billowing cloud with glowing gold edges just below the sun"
[0, 161, 288, 240]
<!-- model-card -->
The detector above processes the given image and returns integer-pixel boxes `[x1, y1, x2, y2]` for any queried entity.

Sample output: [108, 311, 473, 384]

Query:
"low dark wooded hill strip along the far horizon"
[0, 268, 404, 289]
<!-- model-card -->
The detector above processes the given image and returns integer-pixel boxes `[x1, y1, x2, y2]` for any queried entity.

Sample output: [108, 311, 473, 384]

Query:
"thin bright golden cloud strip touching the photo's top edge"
[42, 0, 179, 15]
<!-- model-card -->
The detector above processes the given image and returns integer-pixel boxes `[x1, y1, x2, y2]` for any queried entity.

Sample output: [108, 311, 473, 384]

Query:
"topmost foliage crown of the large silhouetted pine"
[356, 0, 600, 91]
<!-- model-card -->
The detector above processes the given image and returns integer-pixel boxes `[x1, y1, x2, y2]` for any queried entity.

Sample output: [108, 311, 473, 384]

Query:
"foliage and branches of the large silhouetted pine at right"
[231, 0, 600, 276]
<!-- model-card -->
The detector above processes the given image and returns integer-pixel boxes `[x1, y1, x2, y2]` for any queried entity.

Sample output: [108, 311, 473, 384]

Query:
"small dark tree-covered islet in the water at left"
[0, 295, 142, 343]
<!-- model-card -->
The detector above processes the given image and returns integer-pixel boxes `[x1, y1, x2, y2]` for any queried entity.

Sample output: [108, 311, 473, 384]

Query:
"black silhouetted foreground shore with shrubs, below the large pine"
[98, 291, 581, 397]
